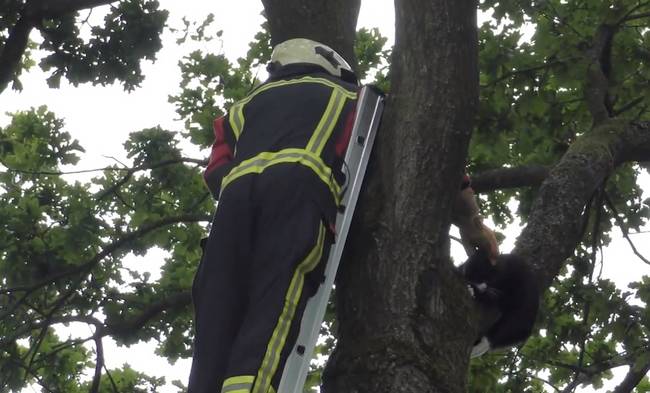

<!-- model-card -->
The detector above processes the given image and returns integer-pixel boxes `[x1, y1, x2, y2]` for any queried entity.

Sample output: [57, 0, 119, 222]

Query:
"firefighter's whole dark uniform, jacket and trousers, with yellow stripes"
[188, 66, 357, 393]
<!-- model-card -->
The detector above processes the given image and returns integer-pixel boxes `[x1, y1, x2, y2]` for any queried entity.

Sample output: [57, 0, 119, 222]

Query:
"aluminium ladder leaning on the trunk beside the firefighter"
[278, 86, 384, 393]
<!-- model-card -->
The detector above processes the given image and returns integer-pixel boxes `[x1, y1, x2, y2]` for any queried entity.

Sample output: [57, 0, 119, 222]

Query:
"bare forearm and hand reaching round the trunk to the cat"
[452, 181, 499, 263]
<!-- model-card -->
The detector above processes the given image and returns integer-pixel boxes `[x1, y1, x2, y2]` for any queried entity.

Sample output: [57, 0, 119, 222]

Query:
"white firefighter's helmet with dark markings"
[271, 38, 356, 80]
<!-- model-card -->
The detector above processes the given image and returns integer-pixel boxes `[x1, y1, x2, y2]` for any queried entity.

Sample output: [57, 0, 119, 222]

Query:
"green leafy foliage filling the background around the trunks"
[0, 0, 650, 393]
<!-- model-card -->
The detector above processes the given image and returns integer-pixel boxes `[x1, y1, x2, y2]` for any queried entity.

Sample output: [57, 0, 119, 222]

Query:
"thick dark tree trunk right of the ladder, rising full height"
[323, 0, 478, 393]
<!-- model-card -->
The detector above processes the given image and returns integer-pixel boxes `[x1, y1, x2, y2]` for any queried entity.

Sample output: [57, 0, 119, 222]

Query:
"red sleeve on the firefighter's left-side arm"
[203, 116, 236, 199]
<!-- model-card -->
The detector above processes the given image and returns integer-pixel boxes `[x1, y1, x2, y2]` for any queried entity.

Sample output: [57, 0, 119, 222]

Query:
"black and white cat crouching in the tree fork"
[459, 249, 540, 357]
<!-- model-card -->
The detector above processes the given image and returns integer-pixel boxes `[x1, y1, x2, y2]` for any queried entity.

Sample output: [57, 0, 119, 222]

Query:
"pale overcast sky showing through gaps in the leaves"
[0, 0, 650, 393]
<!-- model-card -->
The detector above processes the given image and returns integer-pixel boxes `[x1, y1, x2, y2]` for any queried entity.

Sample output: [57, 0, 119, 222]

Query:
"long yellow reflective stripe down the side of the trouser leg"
[252, 223, 325, 393]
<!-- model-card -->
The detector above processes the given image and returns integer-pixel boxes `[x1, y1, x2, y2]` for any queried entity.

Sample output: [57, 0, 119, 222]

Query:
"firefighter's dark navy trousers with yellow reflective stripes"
[189, 164, 333, 393]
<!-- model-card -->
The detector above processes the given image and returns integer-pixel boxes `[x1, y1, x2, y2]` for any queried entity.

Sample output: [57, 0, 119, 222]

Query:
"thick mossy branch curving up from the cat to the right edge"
[514, 120, 650, 288]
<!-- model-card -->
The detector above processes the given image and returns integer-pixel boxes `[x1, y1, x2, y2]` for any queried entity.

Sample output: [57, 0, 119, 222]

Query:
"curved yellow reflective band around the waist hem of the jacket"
[221, 149, 341, 204]
